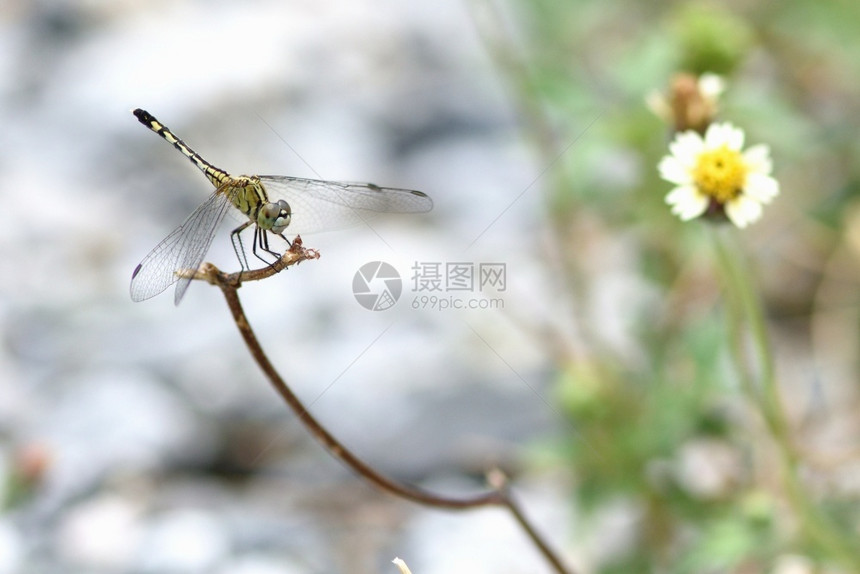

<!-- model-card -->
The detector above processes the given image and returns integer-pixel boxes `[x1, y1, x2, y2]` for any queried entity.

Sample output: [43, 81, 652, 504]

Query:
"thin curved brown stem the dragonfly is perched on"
[194, 246, 575, 574]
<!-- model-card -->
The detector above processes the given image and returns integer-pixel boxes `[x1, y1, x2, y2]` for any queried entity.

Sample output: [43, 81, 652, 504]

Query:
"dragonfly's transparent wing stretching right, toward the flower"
[255, 175, 433, 236]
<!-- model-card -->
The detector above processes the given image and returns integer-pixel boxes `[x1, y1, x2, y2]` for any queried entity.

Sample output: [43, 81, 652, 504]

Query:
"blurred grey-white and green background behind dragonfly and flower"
[0, 0, 860, 574]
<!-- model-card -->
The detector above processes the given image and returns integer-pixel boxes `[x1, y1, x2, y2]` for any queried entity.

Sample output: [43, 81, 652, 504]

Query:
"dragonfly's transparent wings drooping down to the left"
[130, 188, 235, 305]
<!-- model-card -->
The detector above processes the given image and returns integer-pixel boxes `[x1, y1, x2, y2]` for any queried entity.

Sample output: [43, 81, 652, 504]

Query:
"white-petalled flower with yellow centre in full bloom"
[657, 123, 779, 227]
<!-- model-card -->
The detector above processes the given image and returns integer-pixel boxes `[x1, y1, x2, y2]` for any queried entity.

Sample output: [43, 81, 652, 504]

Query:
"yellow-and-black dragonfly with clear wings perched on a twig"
[130, 108, 433, 305]
